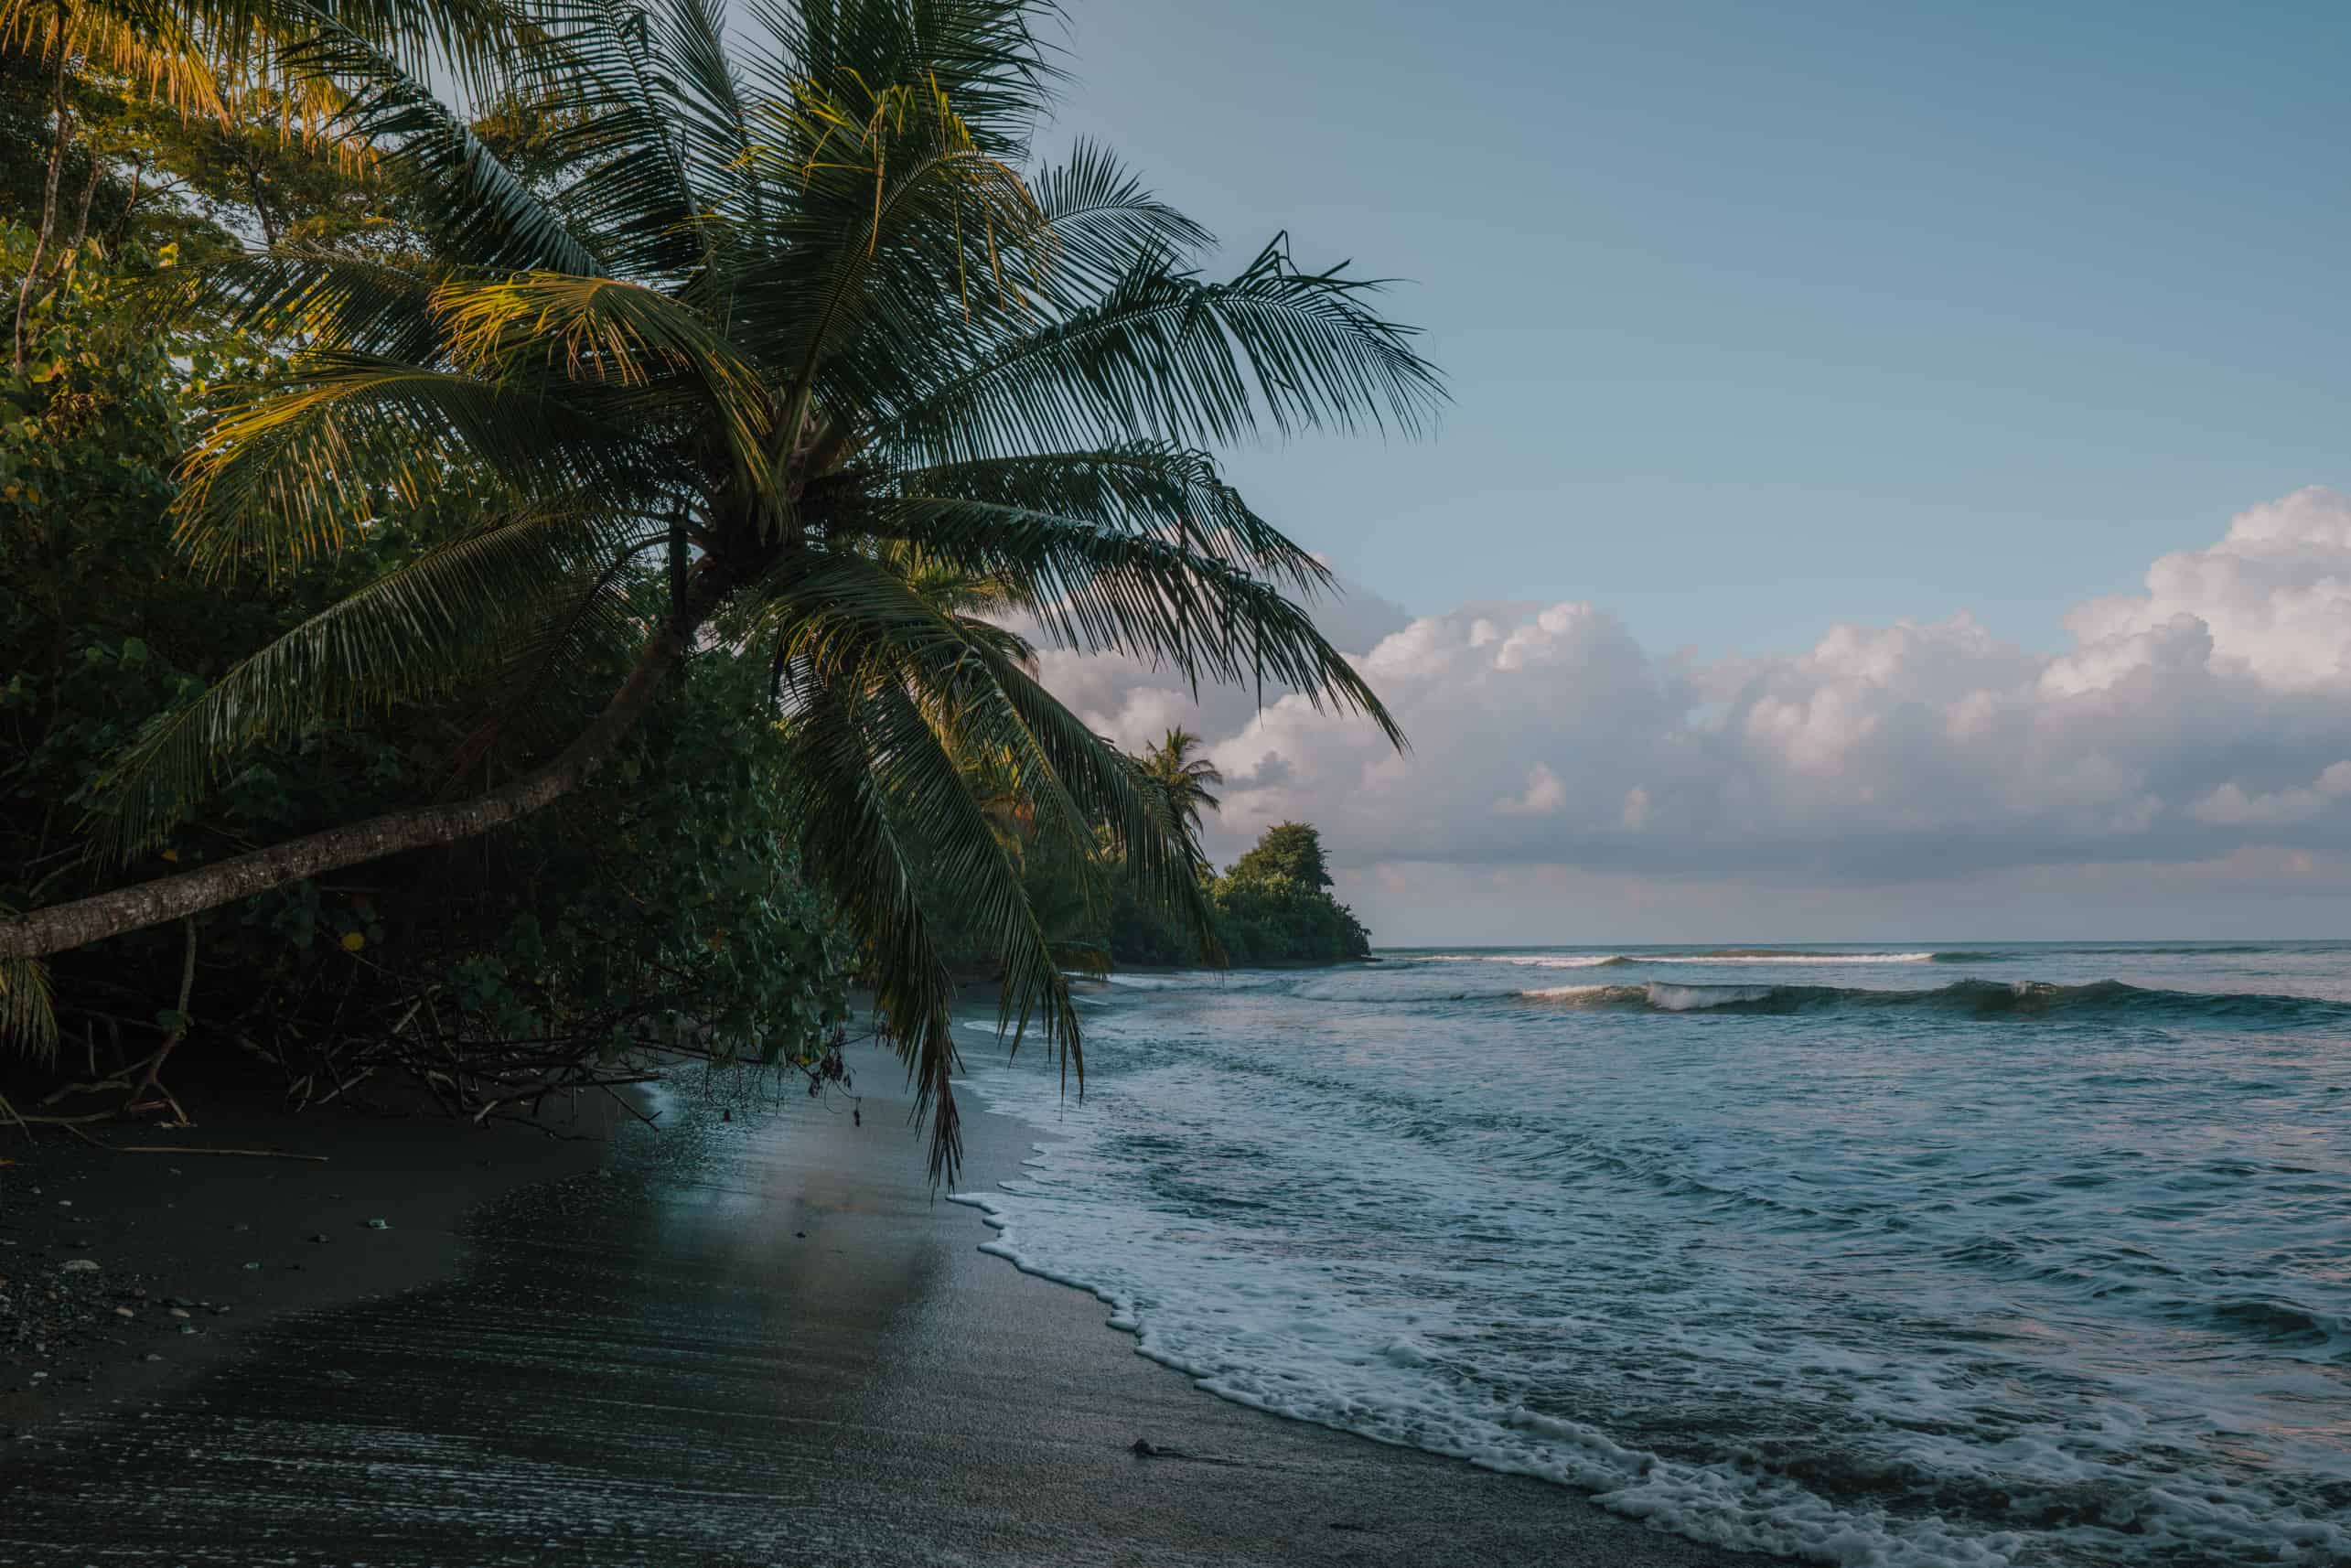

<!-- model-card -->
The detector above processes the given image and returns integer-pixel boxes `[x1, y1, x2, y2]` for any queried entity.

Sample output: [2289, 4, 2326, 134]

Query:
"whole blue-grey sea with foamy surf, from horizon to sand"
[961, 942, 2351, 1565]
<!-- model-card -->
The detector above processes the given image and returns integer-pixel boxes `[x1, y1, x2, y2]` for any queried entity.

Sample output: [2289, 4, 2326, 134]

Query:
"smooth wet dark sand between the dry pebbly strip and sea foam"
[0, 1053, 1749, 1568]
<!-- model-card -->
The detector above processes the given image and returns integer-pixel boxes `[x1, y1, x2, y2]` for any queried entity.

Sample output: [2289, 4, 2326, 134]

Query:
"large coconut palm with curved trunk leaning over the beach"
[0, 0, 1441, 1176]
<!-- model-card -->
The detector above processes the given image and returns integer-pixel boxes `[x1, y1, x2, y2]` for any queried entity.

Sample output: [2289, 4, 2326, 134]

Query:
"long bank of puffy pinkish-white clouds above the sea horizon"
[1047, 489, 2351, 886]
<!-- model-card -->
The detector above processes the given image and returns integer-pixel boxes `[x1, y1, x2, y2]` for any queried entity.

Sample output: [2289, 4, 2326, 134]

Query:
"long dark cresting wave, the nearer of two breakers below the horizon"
[1517, 981, 2351, 1027]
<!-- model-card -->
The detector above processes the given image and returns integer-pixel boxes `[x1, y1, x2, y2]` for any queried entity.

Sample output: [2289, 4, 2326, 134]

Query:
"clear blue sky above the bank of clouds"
[1038, 0, 2351, 653]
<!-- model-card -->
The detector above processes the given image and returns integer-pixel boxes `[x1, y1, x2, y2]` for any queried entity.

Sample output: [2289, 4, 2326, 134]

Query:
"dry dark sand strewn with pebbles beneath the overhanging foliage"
[0, 1090, 628, 1429]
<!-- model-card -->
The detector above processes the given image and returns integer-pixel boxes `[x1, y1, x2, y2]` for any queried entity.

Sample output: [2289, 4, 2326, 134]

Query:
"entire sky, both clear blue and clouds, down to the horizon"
[1011, 0, 2351, 945]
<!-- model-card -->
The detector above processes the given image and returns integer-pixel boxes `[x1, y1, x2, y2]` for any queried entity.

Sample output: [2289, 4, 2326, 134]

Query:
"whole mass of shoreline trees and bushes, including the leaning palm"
[0, 0, 1441, 1173]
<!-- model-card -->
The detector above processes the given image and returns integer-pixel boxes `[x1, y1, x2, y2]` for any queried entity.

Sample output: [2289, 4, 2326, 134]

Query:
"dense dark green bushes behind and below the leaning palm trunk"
[0, 231, 851, 1110]
